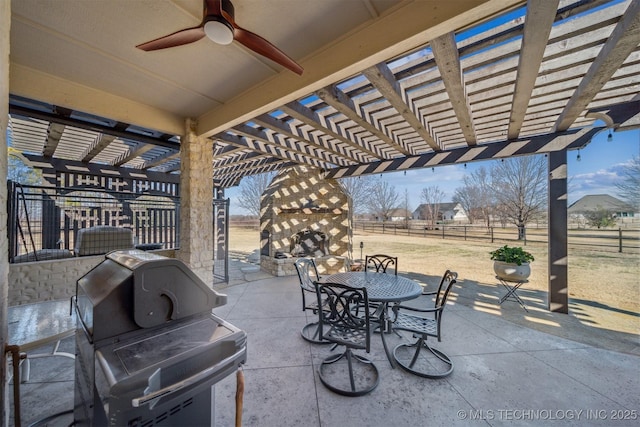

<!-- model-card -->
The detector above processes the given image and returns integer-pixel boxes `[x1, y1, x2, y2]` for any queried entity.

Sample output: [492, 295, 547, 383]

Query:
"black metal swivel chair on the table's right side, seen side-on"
[392, 270, 458, 378]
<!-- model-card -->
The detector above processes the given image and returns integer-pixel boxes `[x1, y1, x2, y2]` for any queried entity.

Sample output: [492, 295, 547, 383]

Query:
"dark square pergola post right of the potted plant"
[548, 150, 569, 313]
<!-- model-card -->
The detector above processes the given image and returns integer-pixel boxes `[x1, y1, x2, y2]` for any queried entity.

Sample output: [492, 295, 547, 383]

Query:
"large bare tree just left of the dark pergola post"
[491, 155, 547, 239]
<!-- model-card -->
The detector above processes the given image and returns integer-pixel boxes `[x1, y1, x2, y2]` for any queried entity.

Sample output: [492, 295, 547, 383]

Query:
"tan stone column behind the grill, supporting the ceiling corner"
[177, 119, 213, 287]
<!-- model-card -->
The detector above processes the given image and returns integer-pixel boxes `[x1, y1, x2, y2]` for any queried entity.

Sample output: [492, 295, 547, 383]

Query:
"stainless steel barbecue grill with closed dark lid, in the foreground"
[74, 250, 246, 427]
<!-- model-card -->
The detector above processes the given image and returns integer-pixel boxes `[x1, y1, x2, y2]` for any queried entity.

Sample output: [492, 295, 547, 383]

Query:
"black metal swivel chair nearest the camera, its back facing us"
[316, 283, 379, 396]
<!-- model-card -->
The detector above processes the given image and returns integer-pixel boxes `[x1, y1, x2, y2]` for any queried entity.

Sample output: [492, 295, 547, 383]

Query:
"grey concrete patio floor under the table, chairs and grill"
[10, 262, 640, 427]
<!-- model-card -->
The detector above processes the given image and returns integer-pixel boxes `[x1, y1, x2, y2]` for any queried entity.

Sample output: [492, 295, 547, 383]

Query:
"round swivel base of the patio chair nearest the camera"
[318, 348, 380, 396]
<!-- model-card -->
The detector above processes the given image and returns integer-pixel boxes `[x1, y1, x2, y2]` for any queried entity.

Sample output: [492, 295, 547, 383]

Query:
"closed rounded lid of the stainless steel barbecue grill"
[76, 249, 227, 340]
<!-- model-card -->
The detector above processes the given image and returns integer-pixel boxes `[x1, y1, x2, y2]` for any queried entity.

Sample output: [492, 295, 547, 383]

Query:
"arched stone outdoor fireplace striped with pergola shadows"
[260, 166, 352, 276]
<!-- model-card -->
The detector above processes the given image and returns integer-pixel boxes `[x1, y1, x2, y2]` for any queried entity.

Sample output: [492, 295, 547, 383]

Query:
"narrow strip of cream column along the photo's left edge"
[0, 0, 11, 426]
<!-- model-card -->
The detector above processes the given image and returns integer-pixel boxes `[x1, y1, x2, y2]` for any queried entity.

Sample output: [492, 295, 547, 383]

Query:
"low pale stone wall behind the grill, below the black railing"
[8, 249, 175, 306]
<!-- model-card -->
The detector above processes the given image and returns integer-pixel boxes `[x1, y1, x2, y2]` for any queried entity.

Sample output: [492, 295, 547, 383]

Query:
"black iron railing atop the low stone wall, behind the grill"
[8, 181, 180, 262]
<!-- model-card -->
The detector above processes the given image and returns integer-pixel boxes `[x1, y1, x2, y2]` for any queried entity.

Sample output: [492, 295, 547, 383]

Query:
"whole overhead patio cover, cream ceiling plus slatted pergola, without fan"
[10, 0, 640, 188]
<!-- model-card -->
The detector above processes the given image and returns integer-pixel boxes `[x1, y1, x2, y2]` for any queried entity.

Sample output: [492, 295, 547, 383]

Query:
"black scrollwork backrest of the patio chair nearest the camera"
[315, 282, 371, 352]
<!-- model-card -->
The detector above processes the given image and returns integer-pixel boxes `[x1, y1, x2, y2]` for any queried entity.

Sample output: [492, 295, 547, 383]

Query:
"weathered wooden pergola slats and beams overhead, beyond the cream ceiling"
[10, 0, 640, 185]
